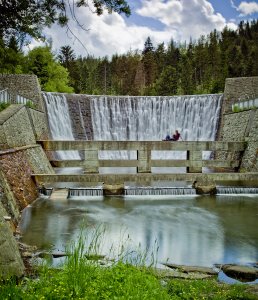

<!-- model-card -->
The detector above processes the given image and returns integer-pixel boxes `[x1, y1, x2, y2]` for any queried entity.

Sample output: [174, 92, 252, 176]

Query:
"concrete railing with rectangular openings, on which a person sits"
[38, 140, 246, 174]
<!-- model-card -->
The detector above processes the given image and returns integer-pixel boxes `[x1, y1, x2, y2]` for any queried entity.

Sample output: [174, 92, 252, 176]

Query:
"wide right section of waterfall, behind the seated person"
[91, 94, 222, 159]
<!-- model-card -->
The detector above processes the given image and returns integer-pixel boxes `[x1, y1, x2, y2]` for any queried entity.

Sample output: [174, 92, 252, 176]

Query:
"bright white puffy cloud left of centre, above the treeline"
[38, 4, 171, 57]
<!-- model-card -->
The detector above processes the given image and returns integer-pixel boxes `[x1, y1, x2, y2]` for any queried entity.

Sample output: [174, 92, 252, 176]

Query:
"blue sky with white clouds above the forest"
[30, 0, 258, 58]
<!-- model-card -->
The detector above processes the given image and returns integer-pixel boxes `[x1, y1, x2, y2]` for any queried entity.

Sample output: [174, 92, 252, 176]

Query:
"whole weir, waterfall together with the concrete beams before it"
[38, 93, 257, 193]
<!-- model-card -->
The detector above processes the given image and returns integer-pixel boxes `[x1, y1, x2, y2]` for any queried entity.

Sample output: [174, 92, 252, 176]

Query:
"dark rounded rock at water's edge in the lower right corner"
[221, 265, 258, 282]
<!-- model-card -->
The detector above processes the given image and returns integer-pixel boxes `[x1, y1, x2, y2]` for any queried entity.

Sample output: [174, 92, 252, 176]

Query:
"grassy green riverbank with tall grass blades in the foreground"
[0, 229, 258, 300]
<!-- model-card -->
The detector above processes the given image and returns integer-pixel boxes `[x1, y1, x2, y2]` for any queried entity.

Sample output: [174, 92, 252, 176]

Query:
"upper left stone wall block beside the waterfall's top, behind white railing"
[0, 74, 44, 110]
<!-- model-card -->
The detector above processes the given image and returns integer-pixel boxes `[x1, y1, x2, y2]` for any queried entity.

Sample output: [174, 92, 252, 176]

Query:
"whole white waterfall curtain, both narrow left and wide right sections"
[43, 93, 222, 172]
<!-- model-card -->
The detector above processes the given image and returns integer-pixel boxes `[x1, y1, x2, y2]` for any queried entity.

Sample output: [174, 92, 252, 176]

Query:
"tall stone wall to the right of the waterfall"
[216, 77, 258, 172]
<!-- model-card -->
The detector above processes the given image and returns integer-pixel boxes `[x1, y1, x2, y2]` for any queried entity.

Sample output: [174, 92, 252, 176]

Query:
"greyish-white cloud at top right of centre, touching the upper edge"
[137, 0, 236, 41]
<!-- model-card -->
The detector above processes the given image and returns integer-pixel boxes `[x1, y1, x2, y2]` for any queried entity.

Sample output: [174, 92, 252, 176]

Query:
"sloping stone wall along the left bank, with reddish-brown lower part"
[0, 105, 54, 279]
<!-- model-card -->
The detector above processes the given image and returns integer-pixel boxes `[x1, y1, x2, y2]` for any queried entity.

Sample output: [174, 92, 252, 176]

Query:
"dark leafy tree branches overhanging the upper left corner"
[0, 0, 130, 38]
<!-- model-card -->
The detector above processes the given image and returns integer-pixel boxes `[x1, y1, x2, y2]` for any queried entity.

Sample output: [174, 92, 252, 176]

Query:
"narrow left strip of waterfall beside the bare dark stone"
[43, 93, 80, 159]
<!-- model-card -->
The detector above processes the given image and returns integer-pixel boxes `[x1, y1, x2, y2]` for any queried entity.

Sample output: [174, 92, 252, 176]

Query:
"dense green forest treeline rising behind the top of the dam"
[0, 20, 258, 95]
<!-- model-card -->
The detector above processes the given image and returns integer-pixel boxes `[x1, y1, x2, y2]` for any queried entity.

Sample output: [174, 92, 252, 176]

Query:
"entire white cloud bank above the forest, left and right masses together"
[28, 0, 236, 57]
